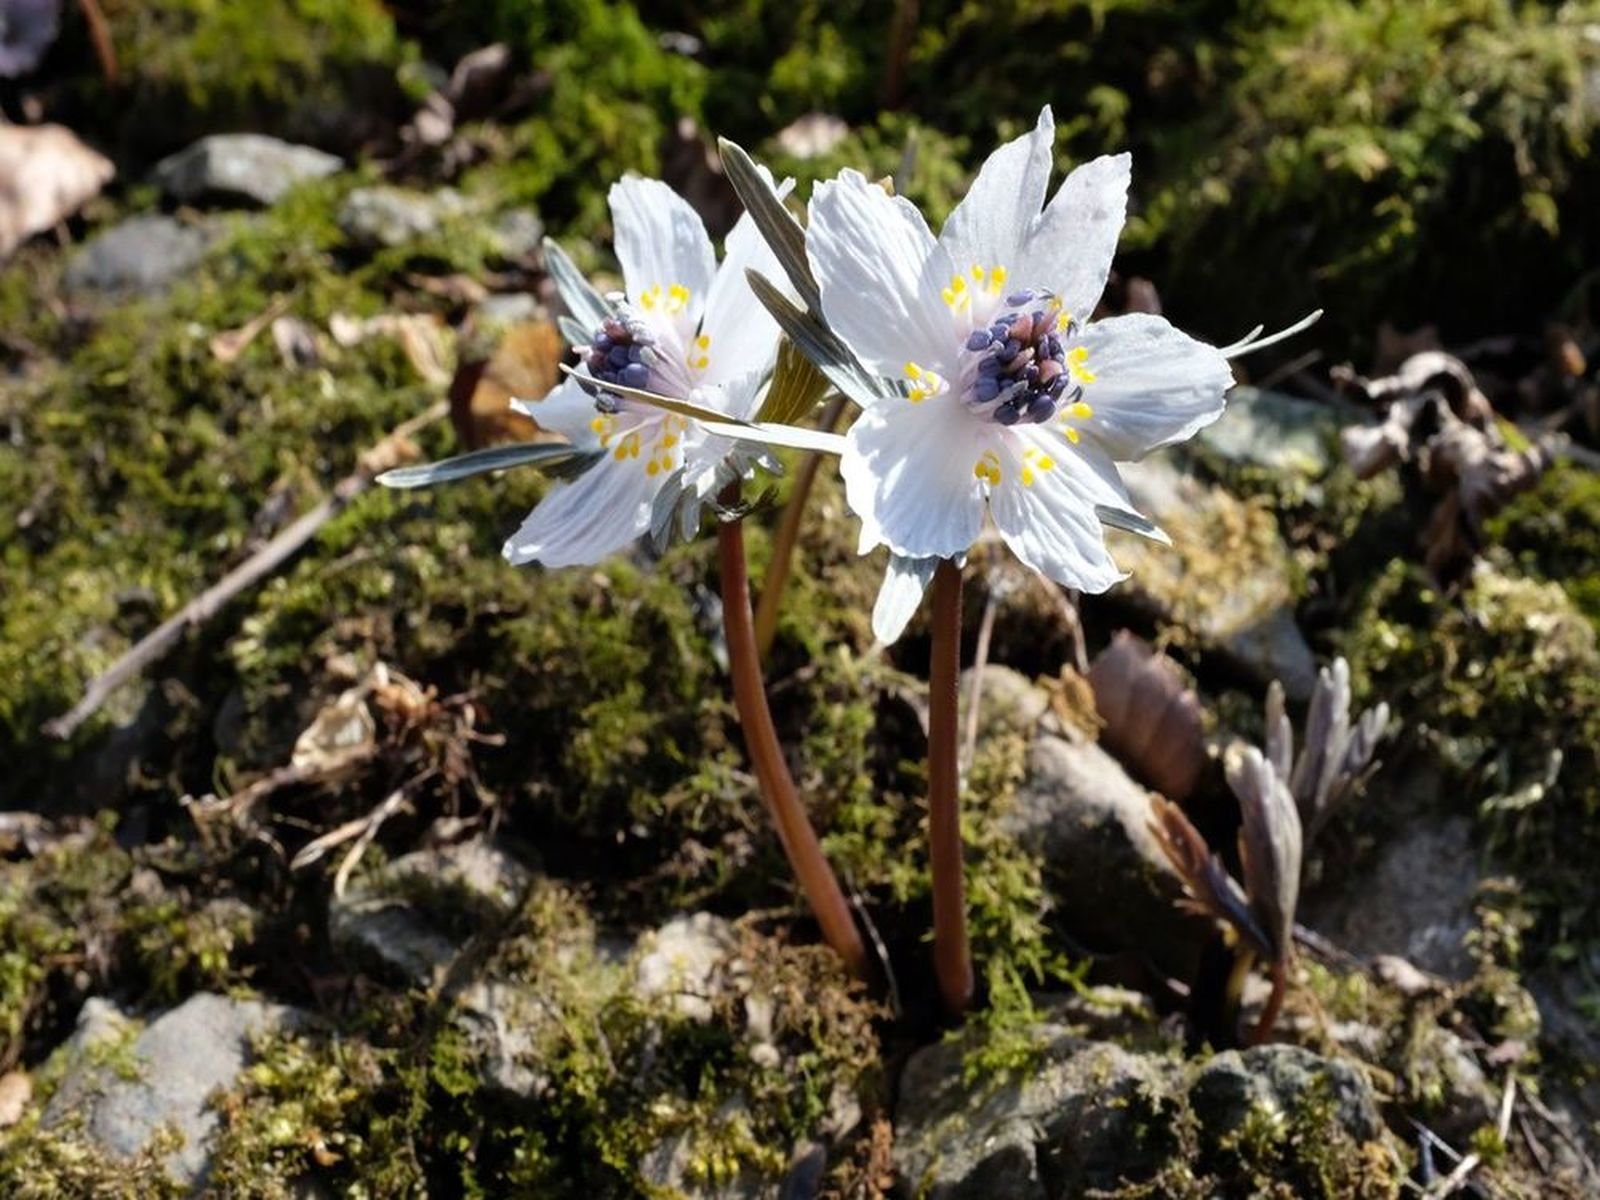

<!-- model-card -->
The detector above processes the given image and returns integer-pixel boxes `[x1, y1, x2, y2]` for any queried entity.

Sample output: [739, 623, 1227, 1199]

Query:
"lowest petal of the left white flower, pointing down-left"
[504, 438, 667, 566]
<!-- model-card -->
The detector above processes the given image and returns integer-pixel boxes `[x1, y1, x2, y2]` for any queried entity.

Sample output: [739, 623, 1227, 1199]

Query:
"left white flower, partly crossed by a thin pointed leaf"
[504, 176, 779, 566]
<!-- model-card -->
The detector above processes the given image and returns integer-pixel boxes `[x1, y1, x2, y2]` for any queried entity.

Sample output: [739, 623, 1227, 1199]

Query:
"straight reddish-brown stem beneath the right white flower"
[928, 558, 973, 1016]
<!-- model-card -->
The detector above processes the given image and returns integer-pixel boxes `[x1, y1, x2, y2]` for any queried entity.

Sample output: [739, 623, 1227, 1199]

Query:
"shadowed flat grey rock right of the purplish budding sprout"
[1304, 816, 1480, 979]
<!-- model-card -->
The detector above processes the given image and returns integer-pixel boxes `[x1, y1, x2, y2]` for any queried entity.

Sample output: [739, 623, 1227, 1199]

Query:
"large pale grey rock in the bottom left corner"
[42, 994, 307, 1192]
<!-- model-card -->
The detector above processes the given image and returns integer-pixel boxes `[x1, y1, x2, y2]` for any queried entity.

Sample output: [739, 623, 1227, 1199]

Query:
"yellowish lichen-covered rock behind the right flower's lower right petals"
[1114, 454, 1317, 701]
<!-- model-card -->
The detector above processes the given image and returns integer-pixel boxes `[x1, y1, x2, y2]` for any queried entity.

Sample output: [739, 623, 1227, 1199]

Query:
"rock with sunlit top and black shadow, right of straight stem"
[1004, 688, 1206, 979]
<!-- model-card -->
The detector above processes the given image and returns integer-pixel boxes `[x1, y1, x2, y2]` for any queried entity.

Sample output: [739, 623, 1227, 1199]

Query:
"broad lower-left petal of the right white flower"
[840, 395, 1000, 558]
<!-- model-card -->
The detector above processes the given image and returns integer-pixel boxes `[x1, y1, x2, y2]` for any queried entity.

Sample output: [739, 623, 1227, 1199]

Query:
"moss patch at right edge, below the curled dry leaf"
[1346, 563, 1600, 949]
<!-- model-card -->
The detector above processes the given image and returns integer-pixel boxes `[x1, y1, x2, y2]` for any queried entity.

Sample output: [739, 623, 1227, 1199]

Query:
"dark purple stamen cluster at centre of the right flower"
[966, 290, 1083, 426]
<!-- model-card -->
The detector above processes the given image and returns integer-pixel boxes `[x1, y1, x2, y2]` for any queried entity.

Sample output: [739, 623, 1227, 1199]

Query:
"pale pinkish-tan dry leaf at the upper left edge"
[0, 123, 117, 259]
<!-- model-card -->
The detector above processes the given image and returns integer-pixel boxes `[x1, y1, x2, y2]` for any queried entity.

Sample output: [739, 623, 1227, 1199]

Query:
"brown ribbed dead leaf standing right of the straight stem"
[1090, 630, 1206, 802]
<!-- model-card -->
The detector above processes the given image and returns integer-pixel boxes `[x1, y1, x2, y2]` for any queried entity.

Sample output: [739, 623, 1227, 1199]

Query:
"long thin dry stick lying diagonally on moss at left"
[43, 402, 450, 741]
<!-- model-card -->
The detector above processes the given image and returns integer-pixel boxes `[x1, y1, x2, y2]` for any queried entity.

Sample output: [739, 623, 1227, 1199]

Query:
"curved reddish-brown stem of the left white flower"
[717, 499, 867, 979]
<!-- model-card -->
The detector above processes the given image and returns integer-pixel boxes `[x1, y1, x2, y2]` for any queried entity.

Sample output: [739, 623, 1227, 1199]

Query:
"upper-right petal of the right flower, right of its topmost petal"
[1018, 154, 1133, 322]
